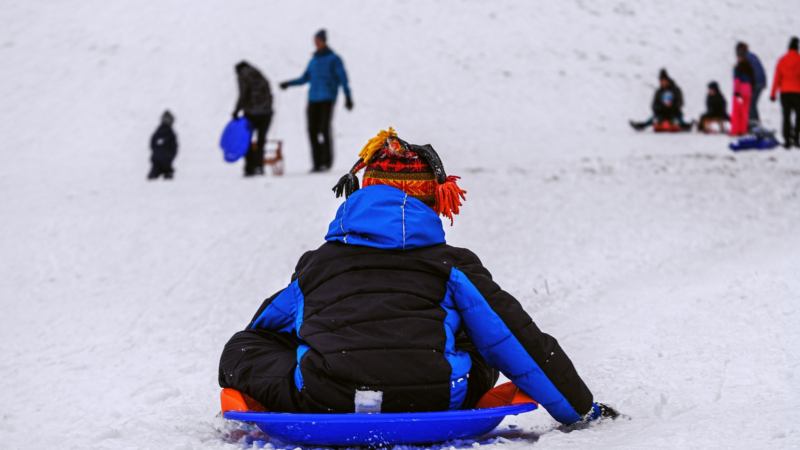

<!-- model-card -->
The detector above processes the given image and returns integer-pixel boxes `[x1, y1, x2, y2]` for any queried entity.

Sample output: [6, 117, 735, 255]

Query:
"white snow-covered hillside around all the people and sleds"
[0, 0, 800, 450]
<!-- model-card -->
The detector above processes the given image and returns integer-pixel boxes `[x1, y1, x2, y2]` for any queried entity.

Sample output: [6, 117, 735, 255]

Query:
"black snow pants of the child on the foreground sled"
[219, 330, 500, 413]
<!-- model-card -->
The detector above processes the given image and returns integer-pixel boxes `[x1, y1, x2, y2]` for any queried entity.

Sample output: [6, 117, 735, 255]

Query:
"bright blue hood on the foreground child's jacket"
[325, 185, 445, 250]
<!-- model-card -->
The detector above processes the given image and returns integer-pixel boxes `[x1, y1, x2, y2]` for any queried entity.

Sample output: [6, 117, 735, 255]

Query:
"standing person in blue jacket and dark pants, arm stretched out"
[280, 30, 353, 172]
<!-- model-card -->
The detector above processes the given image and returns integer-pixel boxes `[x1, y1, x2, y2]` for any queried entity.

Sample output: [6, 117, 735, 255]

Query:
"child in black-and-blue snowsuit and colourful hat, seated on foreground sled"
[219, 128, 617, 424]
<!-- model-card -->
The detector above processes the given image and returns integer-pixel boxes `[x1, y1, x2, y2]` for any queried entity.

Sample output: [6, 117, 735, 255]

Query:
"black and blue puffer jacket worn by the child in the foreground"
[241, 185, 592, 424]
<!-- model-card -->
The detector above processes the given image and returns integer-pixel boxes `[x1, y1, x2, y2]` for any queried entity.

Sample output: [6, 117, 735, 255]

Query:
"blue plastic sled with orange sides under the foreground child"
[221, 383, 538, 446]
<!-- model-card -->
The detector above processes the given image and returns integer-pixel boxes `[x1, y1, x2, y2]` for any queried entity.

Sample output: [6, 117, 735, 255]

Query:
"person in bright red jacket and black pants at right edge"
[769, 37, 800, 150]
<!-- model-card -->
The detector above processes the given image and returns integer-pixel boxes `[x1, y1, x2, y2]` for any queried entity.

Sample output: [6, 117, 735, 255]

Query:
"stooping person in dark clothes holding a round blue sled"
[232, 61, 272, 177]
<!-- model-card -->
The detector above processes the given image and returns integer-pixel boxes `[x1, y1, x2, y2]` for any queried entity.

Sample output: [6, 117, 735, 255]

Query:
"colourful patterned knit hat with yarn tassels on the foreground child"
[333, 127, 467, 225]
